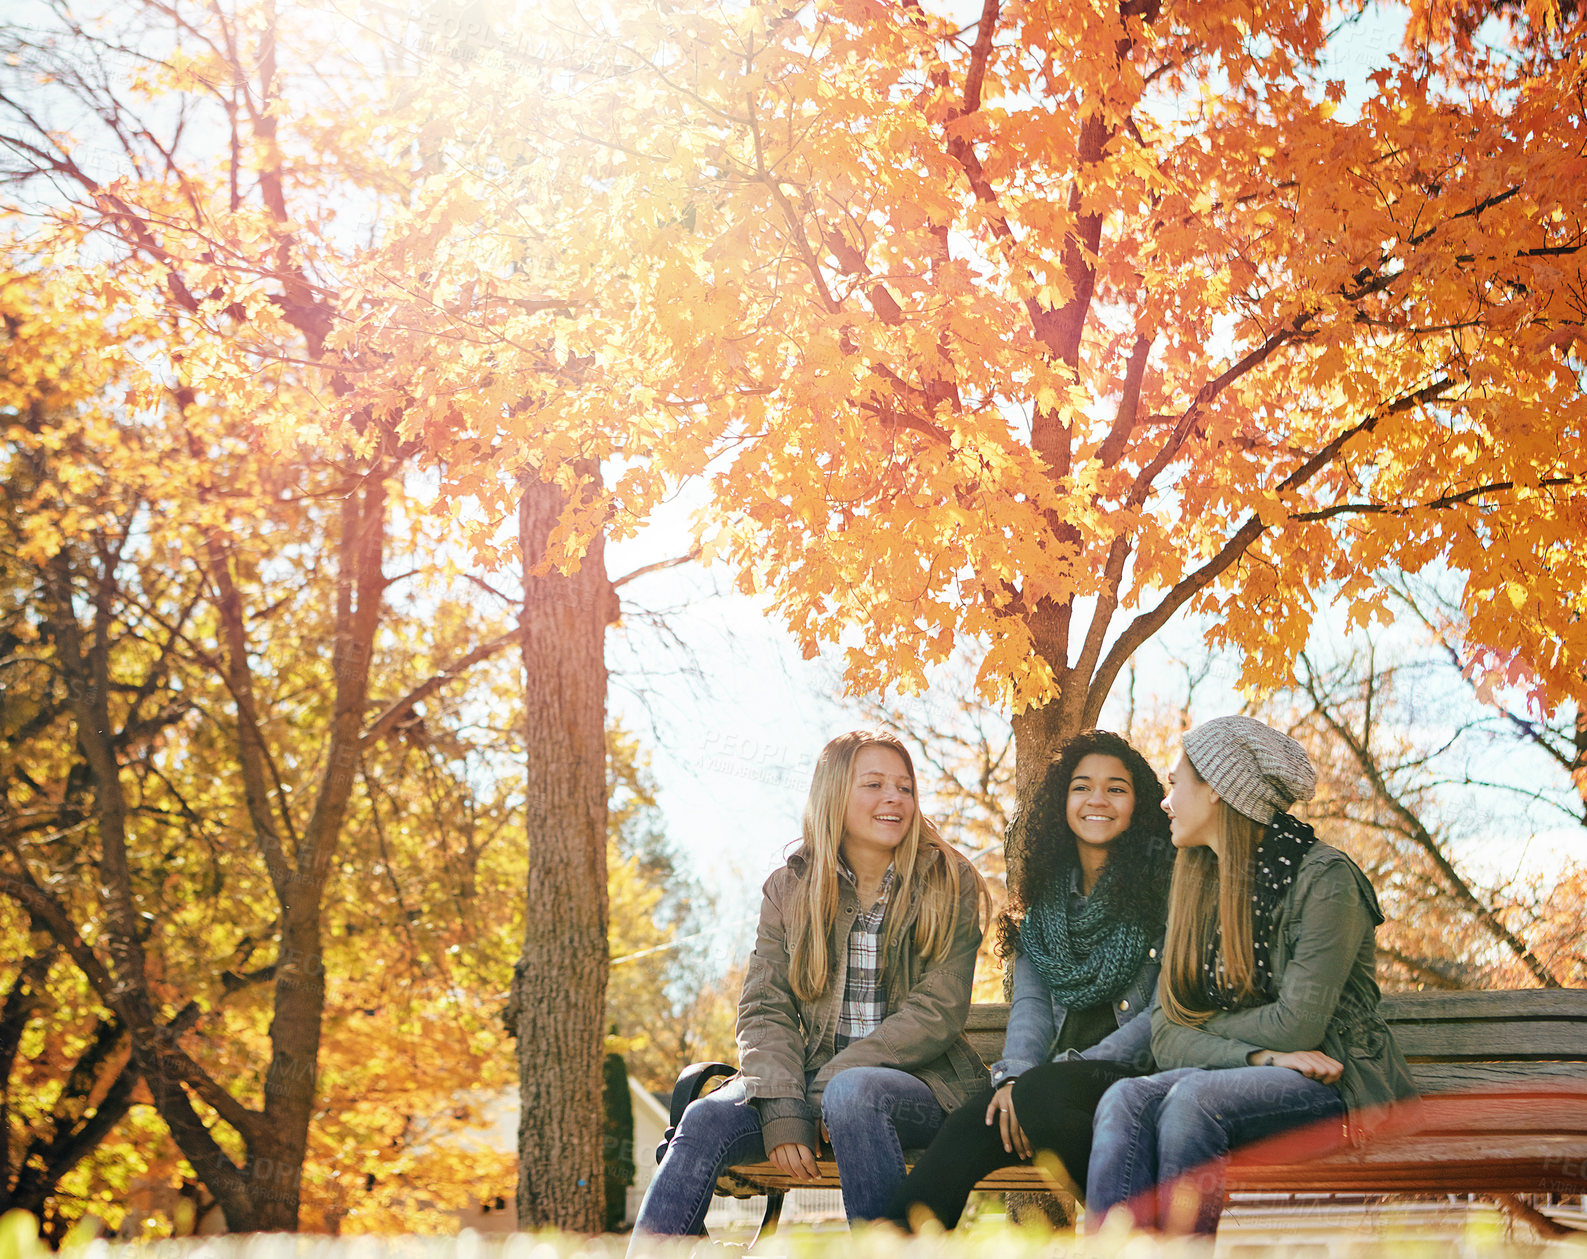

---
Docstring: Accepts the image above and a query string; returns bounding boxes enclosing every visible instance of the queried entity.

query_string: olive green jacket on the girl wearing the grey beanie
[1152,841,1416,1135]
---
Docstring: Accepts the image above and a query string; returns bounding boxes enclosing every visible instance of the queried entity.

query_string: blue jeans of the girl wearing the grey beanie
[1086,1067,1344,1234]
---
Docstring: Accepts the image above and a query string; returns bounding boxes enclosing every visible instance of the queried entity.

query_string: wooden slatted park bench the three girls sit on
[657,989,1587,1234]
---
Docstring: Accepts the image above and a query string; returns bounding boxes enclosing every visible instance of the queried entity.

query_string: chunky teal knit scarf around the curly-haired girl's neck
[1019,872,1151,1010]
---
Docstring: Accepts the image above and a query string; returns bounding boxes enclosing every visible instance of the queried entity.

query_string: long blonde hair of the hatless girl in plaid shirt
[789,730,986,1000]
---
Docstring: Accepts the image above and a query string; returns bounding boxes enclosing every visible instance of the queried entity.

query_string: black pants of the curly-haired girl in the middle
[887,1061,1141,1229]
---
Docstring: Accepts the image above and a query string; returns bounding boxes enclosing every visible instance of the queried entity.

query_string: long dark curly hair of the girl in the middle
[997,730,1174,961]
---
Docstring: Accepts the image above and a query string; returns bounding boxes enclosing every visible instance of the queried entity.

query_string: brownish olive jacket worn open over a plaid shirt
[738,846,987,1151]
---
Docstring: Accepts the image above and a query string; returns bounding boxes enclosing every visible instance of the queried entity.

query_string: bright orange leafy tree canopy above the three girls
[367,0,1584,790]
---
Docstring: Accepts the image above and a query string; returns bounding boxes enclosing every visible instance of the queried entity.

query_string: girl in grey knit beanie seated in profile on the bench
[1087,716,1416,1234]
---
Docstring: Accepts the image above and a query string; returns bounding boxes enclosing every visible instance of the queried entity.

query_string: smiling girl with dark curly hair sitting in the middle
[889,730,1173,1227]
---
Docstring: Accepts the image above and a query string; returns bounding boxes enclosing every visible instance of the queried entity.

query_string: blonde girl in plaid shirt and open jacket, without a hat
[635,730,986,1237]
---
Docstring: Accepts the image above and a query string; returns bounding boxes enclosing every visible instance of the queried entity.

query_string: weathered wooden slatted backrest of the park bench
[965,988,1587,1092]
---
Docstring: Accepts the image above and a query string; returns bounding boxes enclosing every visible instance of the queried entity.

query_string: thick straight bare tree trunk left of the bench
[513,465,617,1234]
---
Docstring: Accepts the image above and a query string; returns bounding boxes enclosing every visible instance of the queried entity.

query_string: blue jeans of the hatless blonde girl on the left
[633,1067,943,1238]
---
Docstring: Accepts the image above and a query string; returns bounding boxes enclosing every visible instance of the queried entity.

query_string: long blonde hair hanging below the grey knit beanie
[1157,757,1266,1027]
